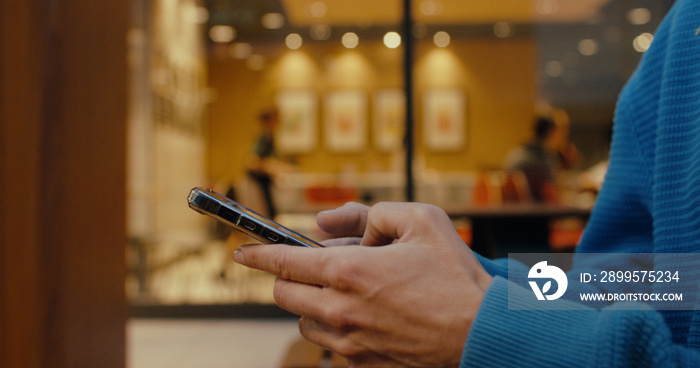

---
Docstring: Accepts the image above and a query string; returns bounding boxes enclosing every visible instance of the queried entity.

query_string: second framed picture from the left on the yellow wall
[324,90,367,152]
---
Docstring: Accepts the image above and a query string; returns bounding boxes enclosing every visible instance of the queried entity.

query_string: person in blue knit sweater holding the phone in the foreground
[228,0,700,367]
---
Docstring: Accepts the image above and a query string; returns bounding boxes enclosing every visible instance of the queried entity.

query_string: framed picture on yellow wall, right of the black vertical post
[423,88,465,151]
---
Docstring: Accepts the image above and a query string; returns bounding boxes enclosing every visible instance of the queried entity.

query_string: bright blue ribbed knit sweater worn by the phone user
[460,0,700,367]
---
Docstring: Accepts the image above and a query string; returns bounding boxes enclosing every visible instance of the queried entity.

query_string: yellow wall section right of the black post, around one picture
[416,39,537,171]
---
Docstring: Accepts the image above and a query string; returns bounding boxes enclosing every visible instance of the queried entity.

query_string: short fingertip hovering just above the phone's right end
[316,202,369,236]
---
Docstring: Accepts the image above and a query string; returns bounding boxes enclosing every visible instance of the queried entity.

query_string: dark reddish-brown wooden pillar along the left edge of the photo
[0,0,129,368]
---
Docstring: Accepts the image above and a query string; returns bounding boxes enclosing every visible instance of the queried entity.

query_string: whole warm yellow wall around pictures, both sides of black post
[208,38,536,181]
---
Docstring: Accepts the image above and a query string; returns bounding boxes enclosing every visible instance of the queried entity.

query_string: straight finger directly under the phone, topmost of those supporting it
[233,244,338,286]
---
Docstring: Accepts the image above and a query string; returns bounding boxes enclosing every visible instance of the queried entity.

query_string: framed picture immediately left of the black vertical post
[373,88,406,152]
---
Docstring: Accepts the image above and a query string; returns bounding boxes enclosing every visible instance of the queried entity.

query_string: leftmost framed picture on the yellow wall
[275,90,318,153]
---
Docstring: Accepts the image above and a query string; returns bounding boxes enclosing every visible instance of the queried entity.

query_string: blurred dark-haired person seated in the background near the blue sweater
[506,116,559,203]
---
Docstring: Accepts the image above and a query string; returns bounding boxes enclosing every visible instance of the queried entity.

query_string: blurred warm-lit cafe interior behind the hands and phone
[0,0,672,368]
